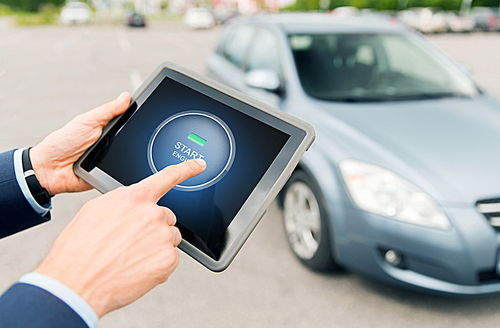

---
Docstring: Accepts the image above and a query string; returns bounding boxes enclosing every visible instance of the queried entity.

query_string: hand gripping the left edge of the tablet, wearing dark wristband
[30,92,130,195]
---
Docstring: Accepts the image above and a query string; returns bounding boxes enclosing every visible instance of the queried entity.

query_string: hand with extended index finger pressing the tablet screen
[35,160,206,317]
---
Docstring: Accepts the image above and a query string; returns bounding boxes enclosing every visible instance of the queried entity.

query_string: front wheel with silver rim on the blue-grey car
[280,170,339,271]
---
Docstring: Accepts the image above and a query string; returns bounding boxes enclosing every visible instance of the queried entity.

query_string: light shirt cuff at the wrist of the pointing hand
[19,272,99,328]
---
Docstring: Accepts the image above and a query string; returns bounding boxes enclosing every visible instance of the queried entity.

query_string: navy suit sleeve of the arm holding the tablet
[0,151,50,238]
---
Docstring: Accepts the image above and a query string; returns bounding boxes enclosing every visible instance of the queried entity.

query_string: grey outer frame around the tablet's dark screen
[74,63,315,272]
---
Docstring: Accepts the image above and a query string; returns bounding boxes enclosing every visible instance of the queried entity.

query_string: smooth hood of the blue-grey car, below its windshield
[309,95,500,205]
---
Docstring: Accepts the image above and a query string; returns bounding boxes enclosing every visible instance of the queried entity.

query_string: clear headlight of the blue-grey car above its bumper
[340,160,451,229]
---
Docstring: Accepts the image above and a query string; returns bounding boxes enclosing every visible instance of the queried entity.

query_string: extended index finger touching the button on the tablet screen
[138,159,207,202]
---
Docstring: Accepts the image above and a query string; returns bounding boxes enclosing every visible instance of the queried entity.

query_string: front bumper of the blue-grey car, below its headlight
[333,205,500,295]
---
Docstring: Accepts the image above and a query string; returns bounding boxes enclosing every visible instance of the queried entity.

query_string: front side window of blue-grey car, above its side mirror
[246,28,280,74]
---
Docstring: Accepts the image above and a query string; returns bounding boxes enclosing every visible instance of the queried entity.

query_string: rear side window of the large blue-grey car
[222,26,255,67]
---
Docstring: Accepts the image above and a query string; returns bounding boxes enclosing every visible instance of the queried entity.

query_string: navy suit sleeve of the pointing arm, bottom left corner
[0,283,88,328]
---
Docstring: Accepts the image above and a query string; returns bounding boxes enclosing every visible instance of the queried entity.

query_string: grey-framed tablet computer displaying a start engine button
[75,64,314,271]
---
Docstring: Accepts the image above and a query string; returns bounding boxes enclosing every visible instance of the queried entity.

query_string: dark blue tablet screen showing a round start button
[82,77,290,260]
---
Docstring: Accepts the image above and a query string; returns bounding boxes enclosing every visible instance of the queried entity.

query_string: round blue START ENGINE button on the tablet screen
[148,110,236,191]
